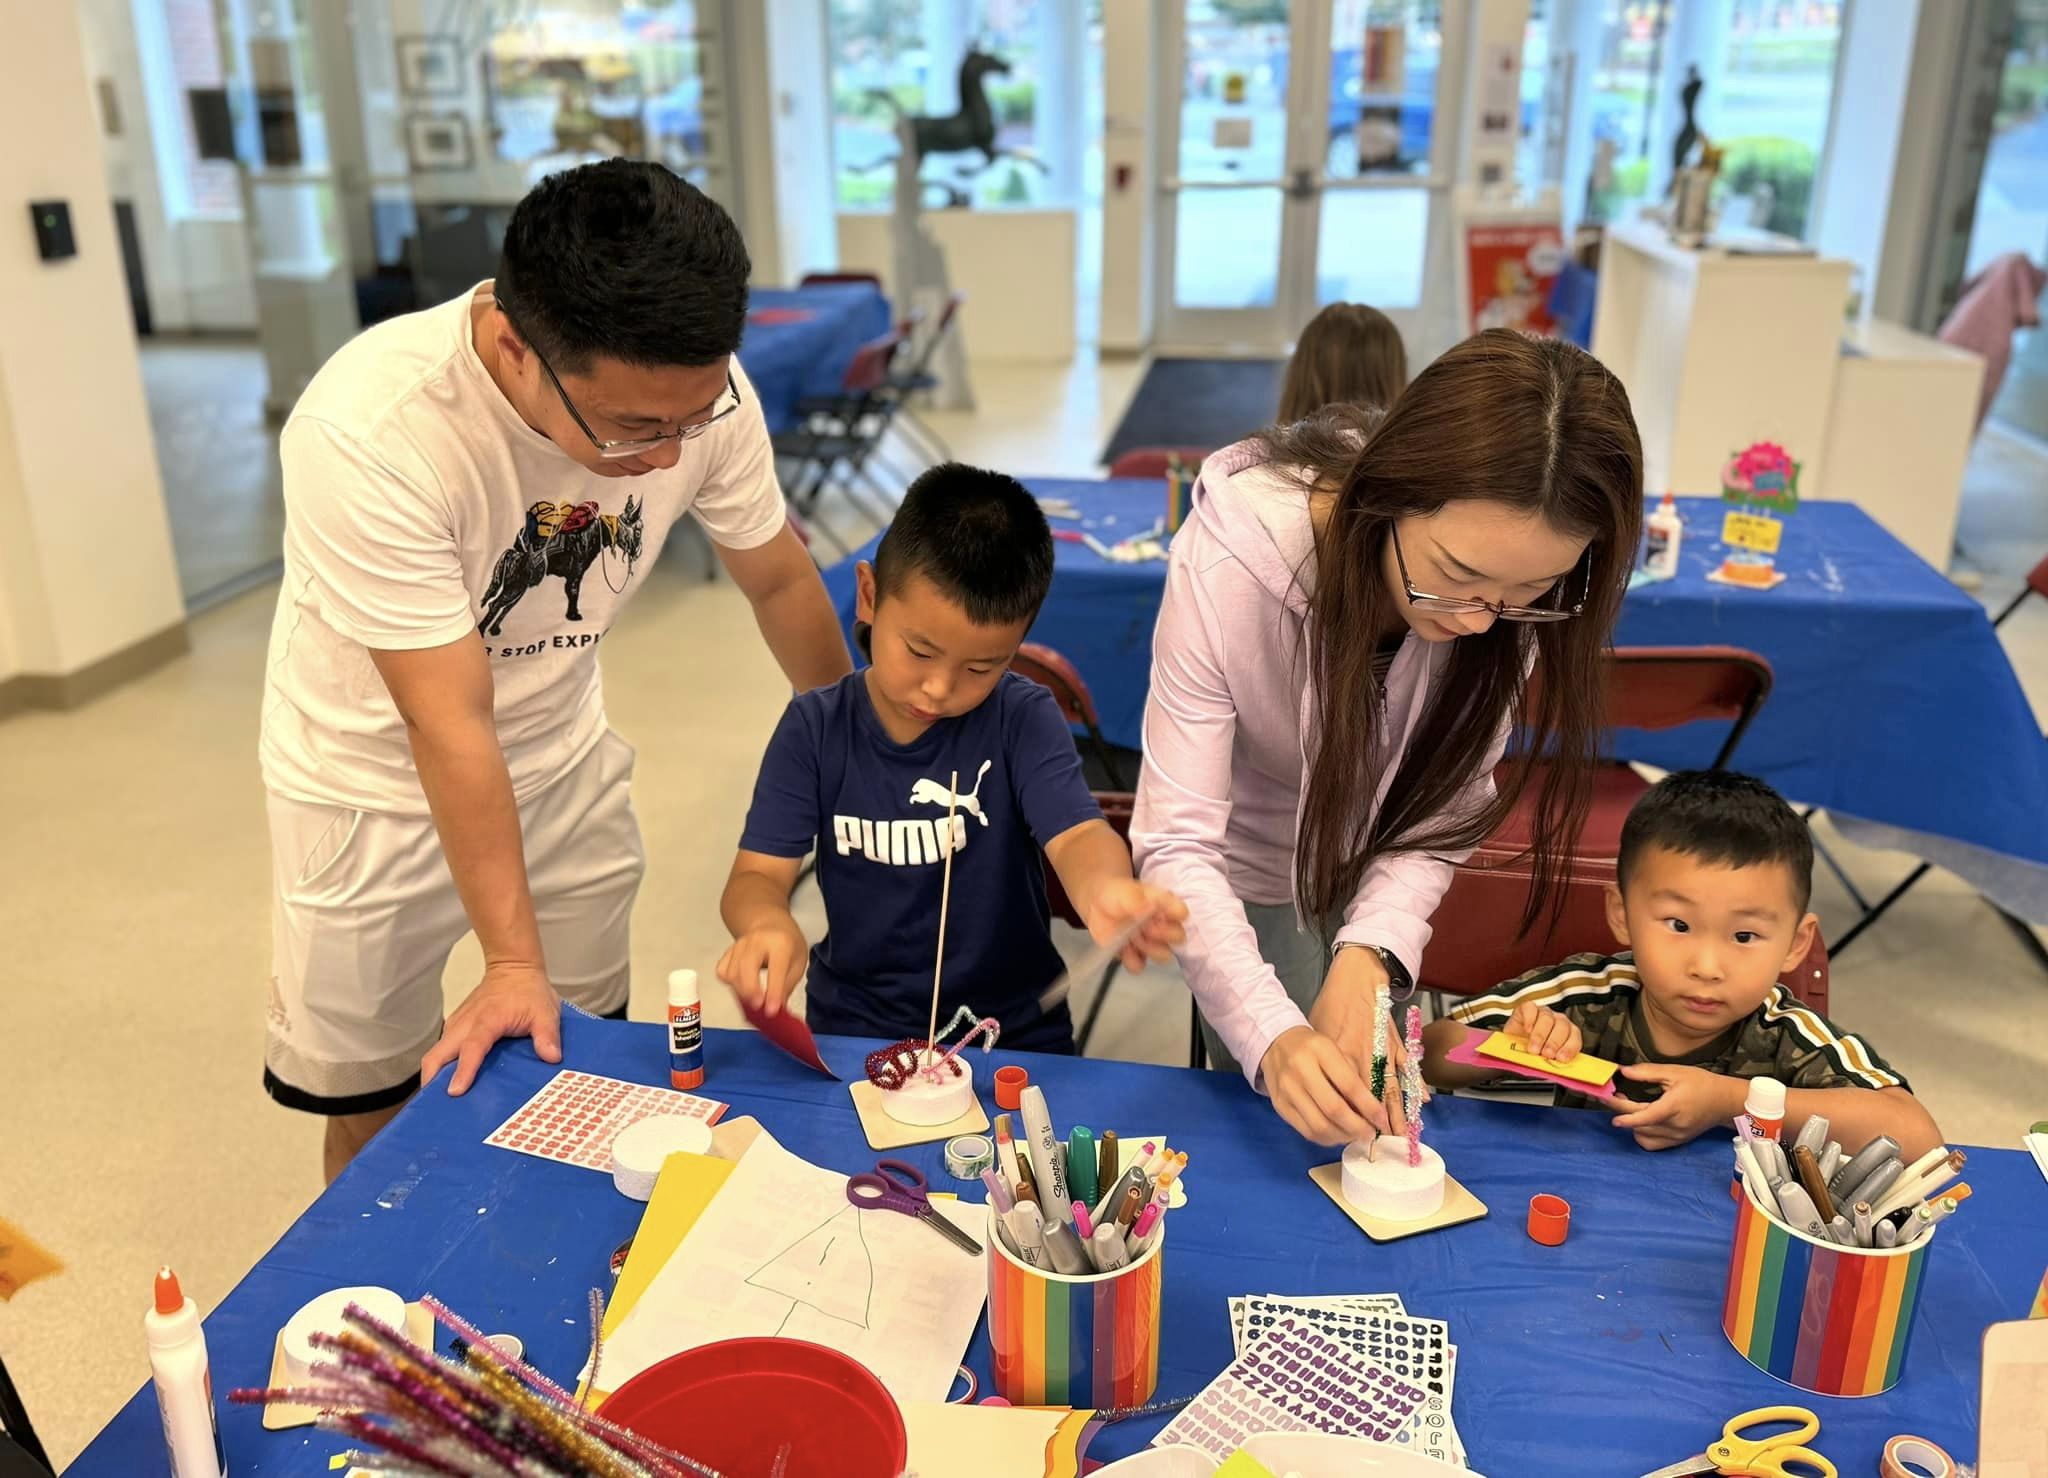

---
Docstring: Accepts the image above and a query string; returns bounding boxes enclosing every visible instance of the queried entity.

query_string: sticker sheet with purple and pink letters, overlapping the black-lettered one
[1151,1318,1430,1460]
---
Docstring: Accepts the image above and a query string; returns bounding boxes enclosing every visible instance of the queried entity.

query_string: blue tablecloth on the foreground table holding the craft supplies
[70,1013,2048,1478]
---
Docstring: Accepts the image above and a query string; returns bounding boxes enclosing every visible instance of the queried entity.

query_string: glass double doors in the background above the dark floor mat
[1155,0,1468,354]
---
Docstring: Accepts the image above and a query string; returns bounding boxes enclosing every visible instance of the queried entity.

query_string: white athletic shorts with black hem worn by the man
[264,729,647,1114]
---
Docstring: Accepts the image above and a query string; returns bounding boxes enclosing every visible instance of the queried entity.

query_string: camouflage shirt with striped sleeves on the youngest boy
[1450,954,1909,1112]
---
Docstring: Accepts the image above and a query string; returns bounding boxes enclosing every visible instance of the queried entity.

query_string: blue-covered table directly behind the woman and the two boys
[823,477,2048,923]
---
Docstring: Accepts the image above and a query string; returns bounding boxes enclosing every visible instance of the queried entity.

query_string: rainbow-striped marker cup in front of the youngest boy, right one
[1720,1162,1942,1396]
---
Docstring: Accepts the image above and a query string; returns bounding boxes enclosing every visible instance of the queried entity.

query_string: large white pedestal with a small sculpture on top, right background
[1593,221,1855,497]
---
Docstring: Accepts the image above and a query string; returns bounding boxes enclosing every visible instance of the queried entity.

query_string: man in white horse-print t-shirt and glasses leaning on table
[262,160,850,1179]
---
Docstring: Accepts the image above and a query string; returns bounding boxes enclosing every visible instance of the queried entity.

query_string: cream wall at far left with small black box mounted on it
[0,6,184,676]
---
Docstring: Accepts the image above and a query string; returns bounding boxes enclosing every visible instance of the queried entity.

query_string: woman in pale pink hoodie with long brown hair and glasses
[1130,330,1642,1144]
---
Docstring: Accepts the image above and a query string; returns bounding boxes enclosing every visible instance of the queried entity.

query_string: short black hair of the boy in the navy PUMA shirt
[874,463,1053,626]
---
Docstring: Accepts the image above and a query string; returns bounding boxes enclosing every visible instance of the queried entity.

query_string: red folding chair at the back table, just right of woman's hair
[1487,647,1772,859]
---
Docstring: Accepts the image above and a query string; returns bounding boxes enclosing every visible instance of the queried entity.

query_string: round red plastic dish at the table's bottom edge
[600,1339,909,1478]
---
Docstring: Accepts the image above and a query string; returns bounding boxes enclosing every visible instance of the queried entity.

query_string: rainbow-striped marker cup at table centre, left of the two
[985,1216,1165,1410]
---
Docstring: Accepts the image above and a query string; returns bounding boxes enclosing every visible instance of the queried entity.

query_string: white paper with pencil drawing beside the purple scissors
[604,1136,987,1400]
